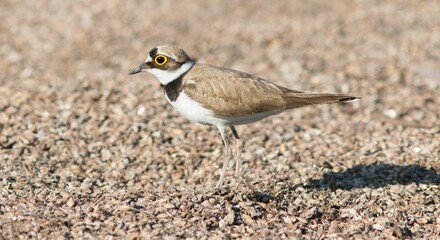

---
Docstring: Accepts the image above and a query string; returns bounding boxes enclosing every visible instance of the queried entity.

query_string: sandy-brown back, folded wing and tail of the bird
[183,64,355,117]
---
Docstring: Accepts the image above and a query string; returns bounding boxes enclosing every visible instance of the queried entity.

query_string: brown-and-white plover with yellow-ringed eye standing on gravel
[129,44,360,188]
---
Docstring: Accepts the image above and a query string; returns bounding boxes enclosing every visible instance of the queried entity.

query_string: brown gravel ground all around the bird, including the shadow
[0,0,440,239]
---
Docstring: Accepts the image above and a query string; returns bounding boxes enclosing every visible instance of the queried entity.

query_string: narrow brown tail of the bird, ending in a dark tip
[283,92,361,109]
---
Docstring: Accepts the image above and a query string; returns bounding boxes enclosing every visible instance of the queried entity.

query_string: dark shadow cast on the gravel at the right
[306,163,440,191]
